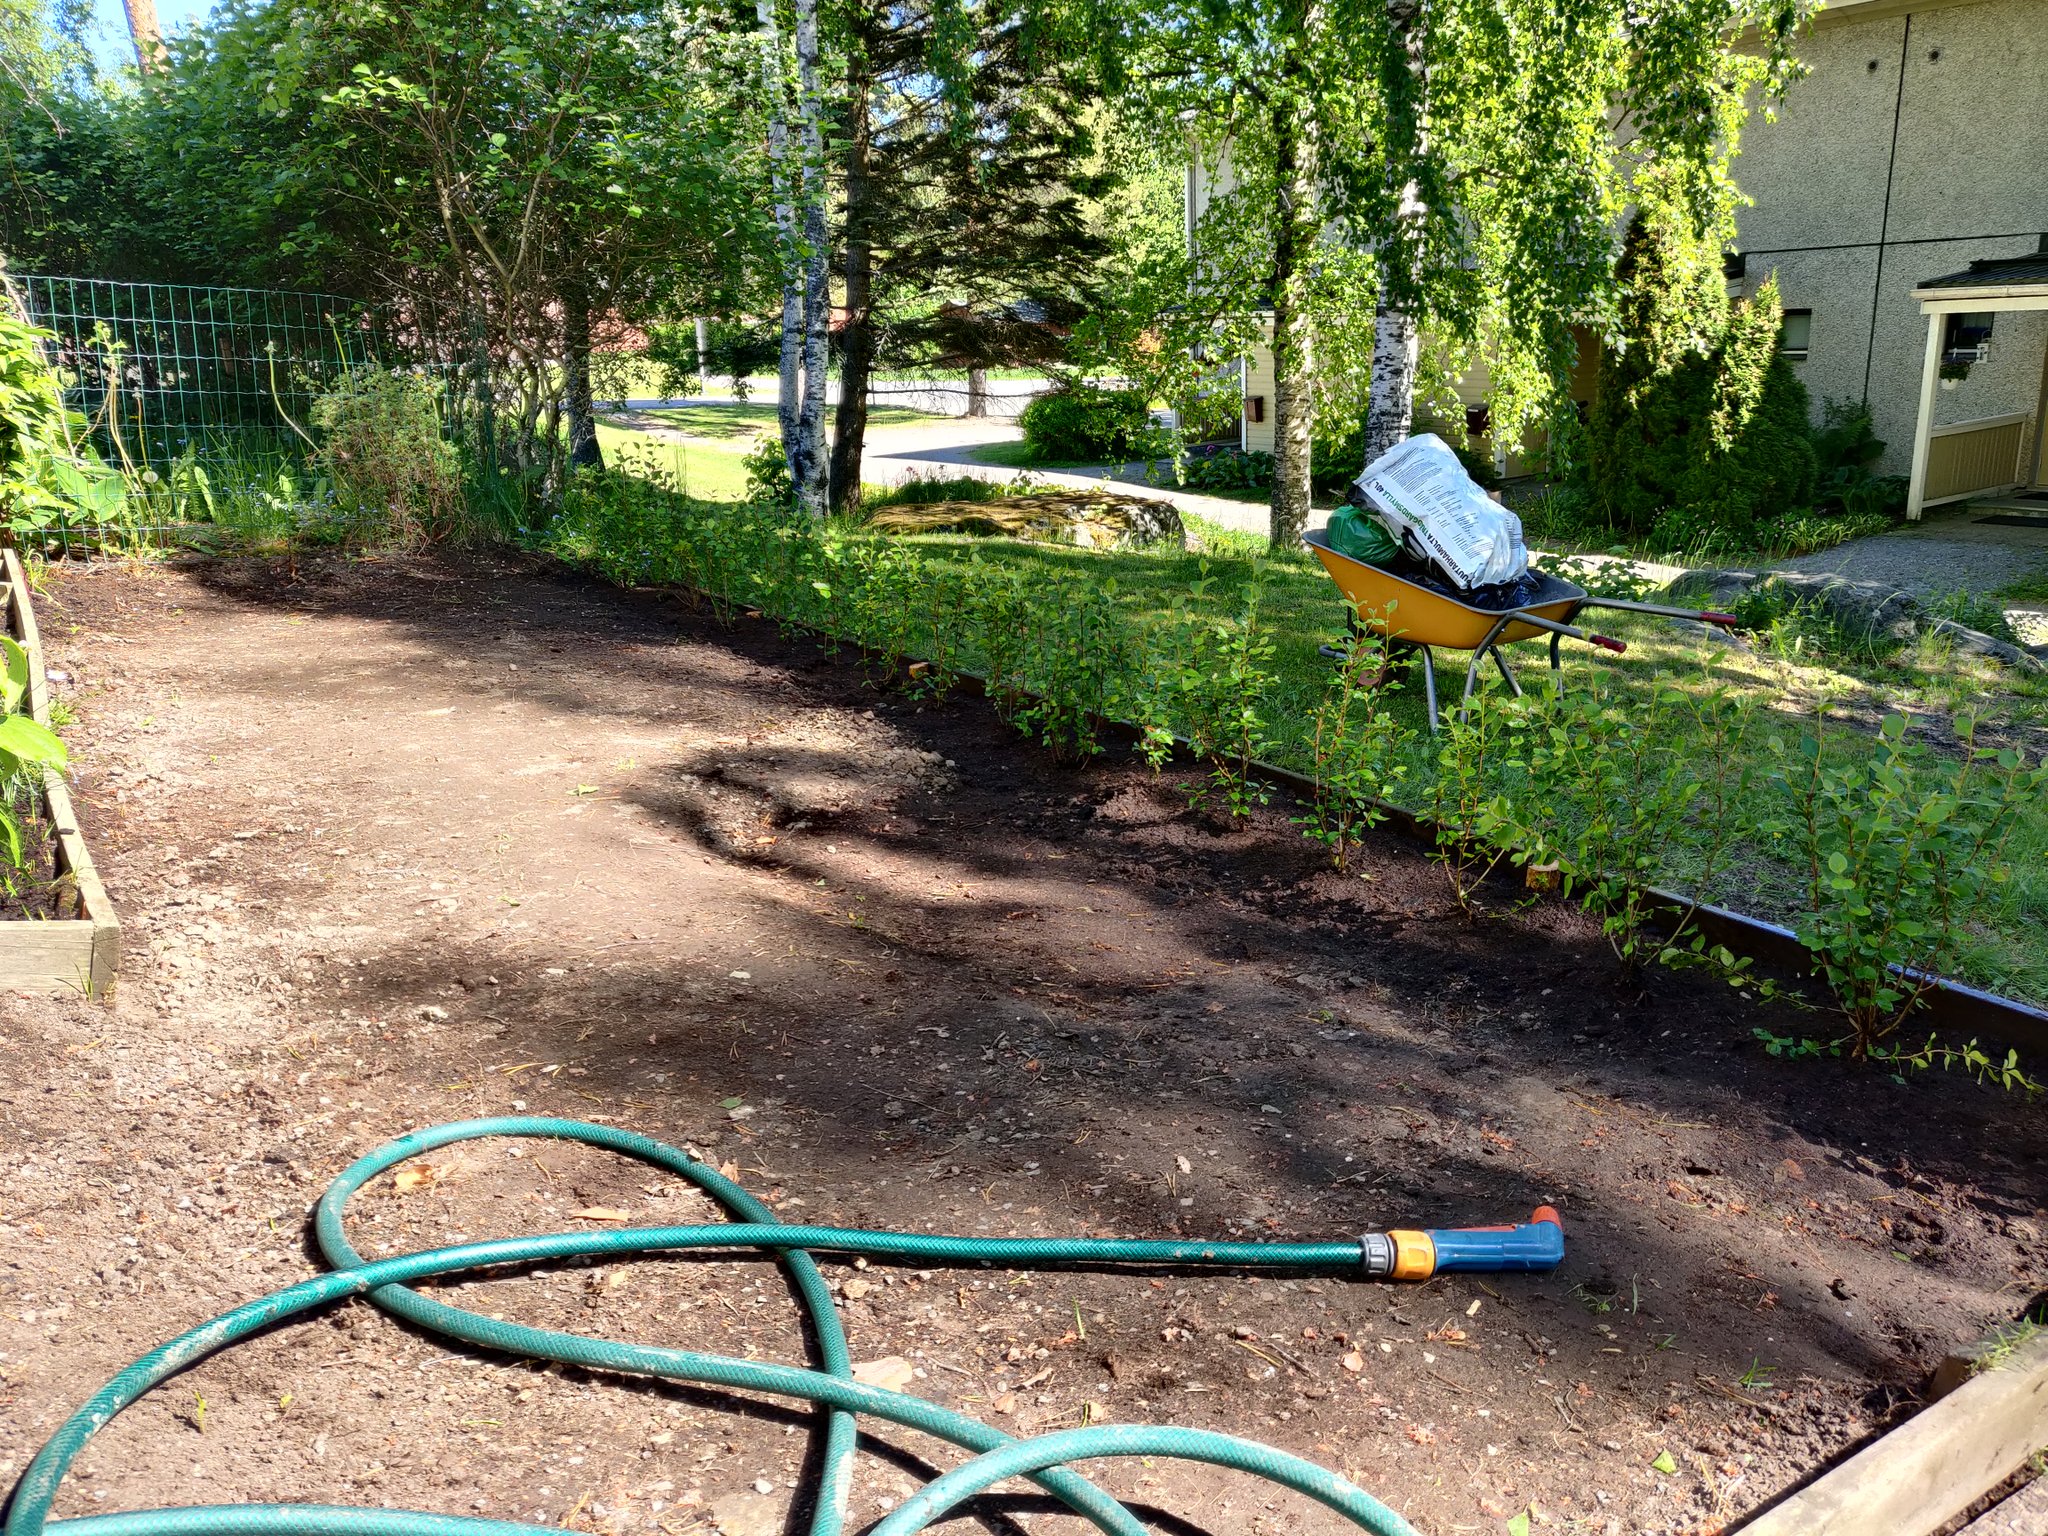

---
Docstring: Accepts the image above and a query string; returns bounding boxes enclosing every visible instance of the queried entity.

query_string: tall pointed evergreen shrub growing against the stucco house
[1587,178,1817,545]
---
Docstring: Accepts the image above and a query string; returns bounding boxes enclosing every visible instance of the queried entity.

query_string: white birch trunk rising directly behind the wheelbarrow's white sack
[1366,0,1432,465]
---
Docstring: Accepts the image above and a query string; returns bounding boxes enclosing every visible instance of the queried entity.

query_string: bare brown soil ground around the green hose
[0,559,2048,1536]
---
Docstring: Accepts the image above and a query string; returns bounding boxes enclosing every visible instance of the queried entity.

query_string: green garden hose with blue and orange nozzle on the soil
[4,1116,1565,1536]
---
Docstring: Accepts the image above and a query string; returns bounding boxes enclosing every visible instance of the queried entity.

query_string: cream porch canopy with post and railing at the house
[1907,250,2048,518]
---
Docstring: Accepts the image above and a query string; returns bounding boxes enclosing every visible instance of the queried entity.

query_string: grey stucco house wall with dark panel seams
[1735,0,2048,473]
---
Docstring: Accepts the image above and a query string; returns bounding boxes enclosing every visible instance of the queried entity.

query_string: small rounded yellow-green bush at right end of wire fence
[313,369,463,545]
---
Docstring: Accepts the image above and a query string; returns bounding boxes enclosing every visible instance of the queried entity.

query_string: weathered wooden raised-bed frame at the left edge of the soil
[0,549,121,997]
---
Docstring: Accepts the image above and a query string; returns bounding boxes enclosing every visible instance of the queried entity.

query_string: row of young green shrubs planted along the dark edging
[551,473,2048,1083]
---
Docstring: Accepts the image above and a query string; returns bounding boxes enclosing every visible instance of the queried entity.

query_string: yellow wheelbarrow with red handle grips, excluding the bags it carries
[1300,528,1735,731]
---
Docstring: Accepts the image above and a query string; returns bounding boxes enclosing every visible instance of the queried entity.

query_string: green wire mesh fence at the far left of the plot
[8,272,379,553]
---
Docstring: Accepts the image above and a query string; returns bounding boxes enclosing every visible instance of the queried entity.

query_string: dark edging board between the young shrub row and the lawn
[692,588,2048,1057]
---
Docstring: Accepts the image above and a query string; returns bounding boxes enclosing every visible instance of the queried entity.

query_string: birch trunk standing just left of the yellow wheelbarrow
[1268,60,1319,551]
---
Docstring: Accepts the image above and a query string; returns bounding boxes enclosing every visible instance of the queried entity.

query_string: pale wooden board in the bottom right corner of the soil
[1733,1331,2048,1536]
